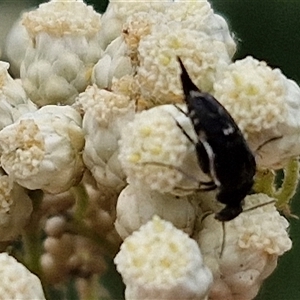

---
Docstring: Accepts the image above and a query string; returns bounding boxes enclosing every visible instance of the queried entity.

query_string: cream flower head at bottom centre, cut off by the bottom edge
[114,216,212,300]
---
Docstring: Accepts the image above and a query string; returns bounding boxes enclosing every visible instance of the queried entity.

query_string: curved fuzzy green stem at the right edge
[274,158,300,209]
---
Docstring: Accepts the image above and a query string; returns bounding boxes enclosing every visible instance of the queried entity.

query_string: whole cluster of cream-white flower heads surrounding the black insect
[0,0,300,300]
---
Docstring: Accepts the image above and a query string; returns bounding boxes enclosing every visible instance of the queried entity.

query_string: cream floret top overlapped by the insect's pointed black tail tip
[137,24,230,105]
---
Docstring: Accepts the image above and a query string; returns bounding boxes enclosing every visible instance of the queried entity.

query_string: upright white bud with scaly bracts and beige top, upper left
[21,0,102,106]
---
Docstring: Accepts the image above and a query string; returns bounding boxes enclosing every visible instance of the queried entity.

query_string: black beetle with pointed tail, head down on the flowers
[178,58,256,221]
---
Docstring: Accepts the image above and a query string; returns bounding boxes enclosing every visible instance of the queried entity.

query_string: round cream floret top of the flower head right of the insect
[214,57,287,135]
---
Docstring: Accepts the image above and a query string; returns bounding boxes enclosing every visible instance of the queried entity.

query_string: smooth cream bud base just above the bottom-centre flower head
[115,185,197,239]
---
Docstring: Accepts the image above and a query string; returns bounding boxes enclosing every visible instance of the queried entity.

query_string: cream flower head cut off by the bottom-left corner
[0,253,46,300]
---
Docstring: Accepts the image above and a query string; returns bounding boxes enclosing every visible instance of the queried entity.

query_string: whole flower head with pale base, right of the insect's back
[214,57,300,169]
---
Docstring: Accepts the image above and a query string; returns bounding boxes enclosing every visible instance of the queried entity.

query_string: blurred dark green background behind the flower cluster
[0,0,300,300]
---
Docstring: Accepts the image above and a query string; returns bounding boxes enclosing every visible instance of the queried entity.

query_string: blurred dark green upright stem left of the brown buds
[22,190,44,278]
